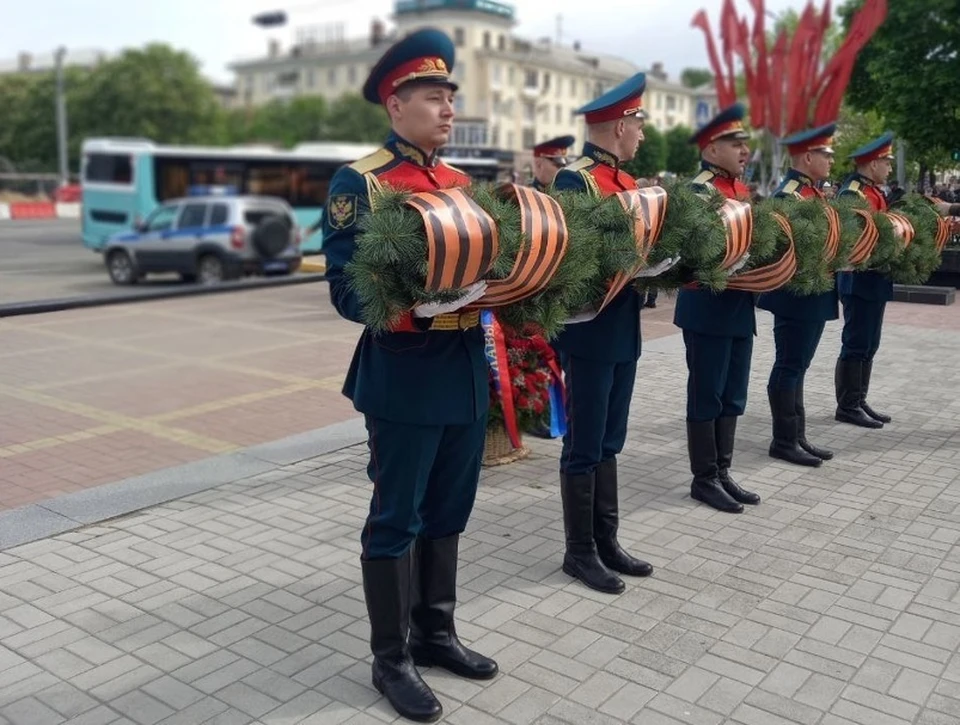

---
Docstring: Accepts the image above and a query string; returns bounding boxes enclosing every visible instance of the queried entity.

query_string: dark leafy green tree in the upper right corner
[840,0,960,181]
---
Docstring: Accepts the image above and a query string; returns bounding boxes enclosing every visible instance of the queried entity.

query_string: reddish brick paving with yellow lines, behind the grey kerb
[0,283,675,511]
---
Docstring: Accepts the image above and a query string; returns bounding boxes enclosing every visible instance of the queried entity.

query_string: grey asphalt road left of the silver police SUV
[0,219,191,304]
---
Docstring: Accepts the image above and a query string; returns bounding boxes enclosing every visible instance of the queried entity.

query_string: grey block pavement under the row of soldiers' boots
[0,316,960,725]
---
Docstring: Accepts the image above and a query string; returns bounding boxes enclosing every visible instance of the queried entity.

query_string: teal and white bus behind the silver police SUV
[81,137,510,254]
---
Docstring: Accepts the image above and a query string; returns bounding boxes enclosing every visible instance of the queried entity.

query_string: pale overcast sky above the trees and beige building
[0,0,804,81]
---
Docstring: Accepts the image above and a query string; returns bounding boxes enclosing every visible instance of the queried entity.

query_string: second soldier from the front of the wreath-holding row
[553,73,653,594]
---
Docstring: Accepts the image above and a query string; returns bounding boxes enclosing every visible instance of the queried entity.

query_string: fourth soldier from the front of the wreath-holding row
[757,123,839,466]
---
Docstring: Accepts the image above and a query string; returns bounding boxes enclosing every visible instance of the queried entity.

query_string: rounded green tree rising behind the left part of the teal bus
[70,43,220,151]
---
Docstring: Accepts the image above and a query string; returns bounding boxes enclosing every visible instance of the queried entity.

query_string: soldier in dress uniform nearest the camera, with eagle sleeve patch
[323,28,497,722]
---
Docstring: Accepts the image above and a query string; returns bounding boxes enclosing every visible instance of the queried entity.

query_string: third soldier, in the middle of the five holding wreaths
[673,103,760,513]
